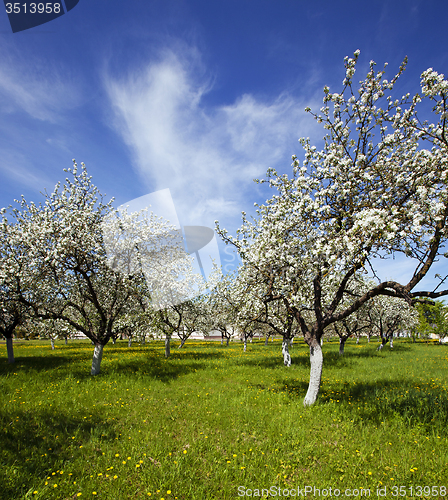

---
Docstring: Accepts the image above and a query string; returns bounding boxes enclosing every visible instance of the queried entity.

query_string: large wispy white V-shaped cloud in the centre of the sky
[105,45,320,229]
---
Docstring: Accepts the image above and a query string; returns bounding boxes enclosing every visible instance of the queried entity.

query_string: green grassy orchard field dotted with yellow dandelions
[0,340,448,500]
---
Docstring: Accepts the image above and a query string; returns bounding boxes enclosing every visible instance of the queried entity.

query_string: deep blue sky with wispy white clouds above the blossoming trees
[0,0,448,294]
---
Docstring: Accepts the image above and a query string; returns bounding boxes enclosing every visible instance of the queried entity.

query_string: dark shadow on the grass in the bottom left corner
[0,408,117,500]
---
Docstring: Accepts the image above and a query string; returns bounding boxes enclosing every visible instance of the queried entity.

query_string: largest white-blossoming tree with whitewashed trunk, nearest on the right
[217,51,448,405]
